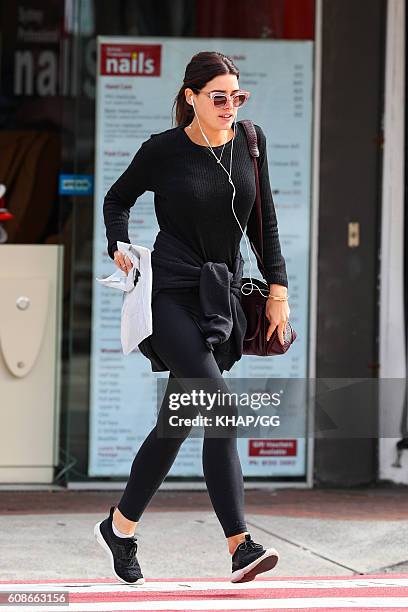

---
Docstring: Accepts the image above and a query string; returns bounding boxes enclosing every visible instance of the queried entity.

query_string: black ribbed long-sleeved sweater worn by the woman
[103,123,288,287]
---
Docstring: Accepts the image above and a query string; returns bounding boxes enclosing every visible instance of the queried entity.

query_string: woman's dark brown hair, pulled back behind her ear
[172,51,239,126]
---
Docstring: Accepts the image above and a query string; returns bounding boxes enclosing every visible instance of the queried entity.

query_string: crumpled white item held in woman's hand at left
[96,241,153,355]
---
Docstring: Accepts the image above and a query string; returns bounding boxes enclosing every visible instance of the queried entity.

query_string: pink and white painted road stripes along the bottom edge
[0,574,408,612]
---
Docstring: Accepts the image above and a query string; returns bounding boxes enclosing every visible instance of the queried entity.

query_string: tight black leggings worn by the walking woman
[118,289,247,537]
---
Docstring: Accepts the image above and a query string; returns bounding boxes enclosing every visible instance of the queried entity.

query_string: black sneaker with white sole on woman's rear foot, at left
[94,506,145,584]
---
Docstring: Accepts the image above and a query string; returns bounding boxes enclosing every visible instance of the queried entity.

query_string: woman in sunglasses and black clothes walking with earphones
[94,52,289,584]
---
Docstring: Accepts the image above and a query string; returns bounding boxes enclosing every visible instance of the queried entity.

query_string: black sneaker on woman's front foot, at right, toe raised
[231,533,279,582]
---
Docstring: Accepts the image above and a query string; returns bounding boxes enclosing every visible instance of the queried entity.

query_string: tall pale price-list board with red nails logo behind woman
[89,37,313,478]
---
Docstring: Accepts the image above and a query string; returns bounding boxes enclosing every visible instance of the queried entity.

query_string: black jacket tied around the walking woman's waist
[138,230,247,372]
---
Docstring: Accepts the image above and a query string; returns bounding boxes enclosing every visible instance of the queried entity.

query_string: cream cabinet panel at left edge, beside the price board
[0,244,63,483]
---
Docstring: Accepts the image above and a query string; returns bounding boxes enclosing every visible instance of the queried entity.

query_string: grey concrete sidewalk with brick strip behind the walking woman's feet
[0,486,408,581]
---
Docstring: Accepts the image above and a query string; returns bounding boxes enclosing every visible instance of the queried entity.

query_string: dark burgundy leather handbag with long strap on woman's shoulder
[239,119,297,356]
